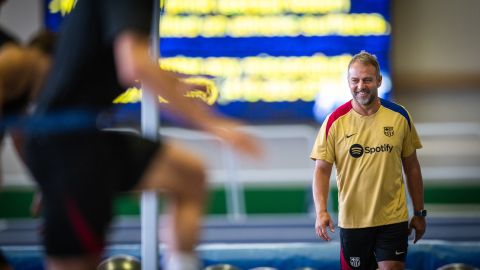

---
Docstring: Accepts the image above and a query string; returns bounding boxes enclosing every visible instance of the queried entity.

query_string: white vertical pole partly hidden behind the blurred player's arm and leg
[140,0,160,270]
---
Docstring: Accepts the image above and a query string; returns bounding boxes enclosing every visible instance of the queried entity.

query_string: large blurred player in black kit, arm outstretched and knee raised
[26,0,259,270]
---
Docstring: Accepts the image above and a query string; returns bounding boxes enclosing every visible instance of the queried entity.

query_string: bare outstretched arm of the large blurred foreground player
[114,31,260,155]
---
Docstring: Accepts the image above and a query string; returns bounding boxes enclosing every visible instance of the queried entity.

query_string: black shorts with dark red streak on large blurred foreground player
[26,131,161,257]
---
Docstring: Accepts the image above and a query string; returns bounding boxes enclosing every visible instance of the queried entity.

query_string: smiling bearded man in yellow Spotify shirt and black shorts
[310,51,426,269]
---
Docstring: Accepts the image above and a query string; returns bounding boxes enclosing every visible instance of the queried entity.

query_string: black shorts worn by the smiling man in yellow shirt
[340,222,408,269]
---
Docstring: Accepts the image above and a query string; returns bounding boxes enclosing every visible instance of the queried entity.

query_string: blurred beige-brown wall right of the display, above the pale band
[392,0,480,122]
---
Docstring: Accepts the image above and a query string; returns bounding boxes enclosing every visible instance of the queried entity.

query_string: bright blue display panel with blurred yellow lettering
[45,0,391,123]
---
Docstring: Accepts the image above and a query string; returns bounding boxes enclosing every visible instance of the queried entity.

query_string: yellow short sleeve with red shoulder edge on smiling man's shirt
[310,115,335,164]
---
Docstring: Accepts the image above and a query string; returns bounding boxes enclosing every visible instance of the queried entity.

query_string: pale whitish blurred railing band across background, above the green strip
[2,123,480,210]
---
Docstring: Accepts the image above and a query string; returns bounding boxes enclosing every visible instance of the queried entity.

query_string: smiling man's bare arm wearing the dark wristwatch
[402,151,427,243]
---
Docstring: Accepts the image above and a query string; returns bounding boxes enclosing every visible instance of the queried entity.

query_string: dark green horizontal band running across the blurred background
[0,184,480,218]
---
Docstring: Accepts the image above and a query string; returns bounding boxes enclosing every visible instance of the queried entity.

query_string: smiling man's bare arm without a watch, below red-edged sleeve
[312,159,334,241]
